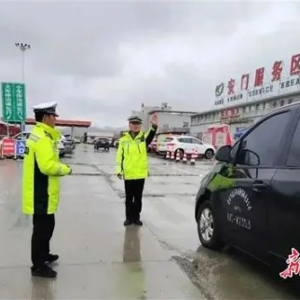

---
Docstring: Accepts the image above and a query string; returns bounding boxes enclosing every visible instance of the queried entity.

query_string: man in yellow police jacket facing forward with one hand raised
[116,114,157,226]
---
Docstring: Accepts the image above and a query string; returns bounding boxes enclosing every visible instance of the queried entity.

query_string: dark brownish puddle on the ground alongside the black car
[172,247,299,300]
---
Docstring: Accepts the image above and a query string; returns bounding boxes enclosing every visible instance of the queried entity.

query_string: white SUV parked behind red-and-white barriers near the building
[156,135,216,159]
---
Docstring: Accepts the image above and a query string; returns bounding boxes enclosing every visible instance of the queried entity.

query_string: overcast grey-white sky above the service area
[0,0,300,126]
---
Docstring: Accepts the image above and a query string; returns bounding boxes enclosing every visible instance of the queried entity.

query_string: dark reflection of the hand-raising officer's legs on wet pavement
[123,226,142,263]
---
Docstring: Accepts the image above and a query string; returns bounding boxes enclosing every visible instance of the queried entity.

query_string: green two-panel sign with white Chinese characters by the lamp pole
[1,82,26,123]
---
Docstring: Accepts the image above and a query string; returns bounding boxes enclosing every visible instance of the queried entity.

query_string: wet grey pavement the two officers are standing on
[0,146,297,299]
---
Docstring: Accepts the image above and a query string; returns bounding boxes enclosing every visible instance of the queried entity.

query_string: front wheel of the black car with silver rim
[197,200,224,250]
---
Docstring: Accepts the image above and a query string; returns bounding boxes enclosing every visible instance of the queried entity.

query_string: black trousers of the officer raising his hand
[125,179,145,221]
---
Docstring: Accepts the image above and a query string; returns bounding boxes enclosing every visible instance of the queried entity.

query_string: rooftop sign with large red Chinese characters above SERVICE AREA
[215,54,300,105]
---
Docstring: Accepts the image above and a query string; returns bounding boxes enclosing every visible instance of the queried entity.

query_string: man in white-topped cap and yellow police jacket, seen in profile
[22,102,72,278]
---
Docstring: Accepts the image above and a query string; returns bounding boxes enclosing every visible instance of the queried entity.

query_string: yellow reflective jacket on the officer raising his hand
[116,127,157,180]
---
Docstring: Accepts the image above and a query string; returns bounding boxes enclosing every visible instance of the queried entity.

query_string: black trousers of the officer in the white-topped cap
[31,214,55,268]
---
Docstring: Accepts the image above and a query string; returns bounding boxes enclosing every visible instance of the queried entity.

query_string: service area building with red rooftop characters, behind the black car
[190,54,300,137]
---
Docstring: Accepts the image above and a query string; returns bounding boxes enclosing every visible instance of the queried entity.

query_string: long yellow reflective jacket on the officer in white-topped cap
[22,123,70,215]
